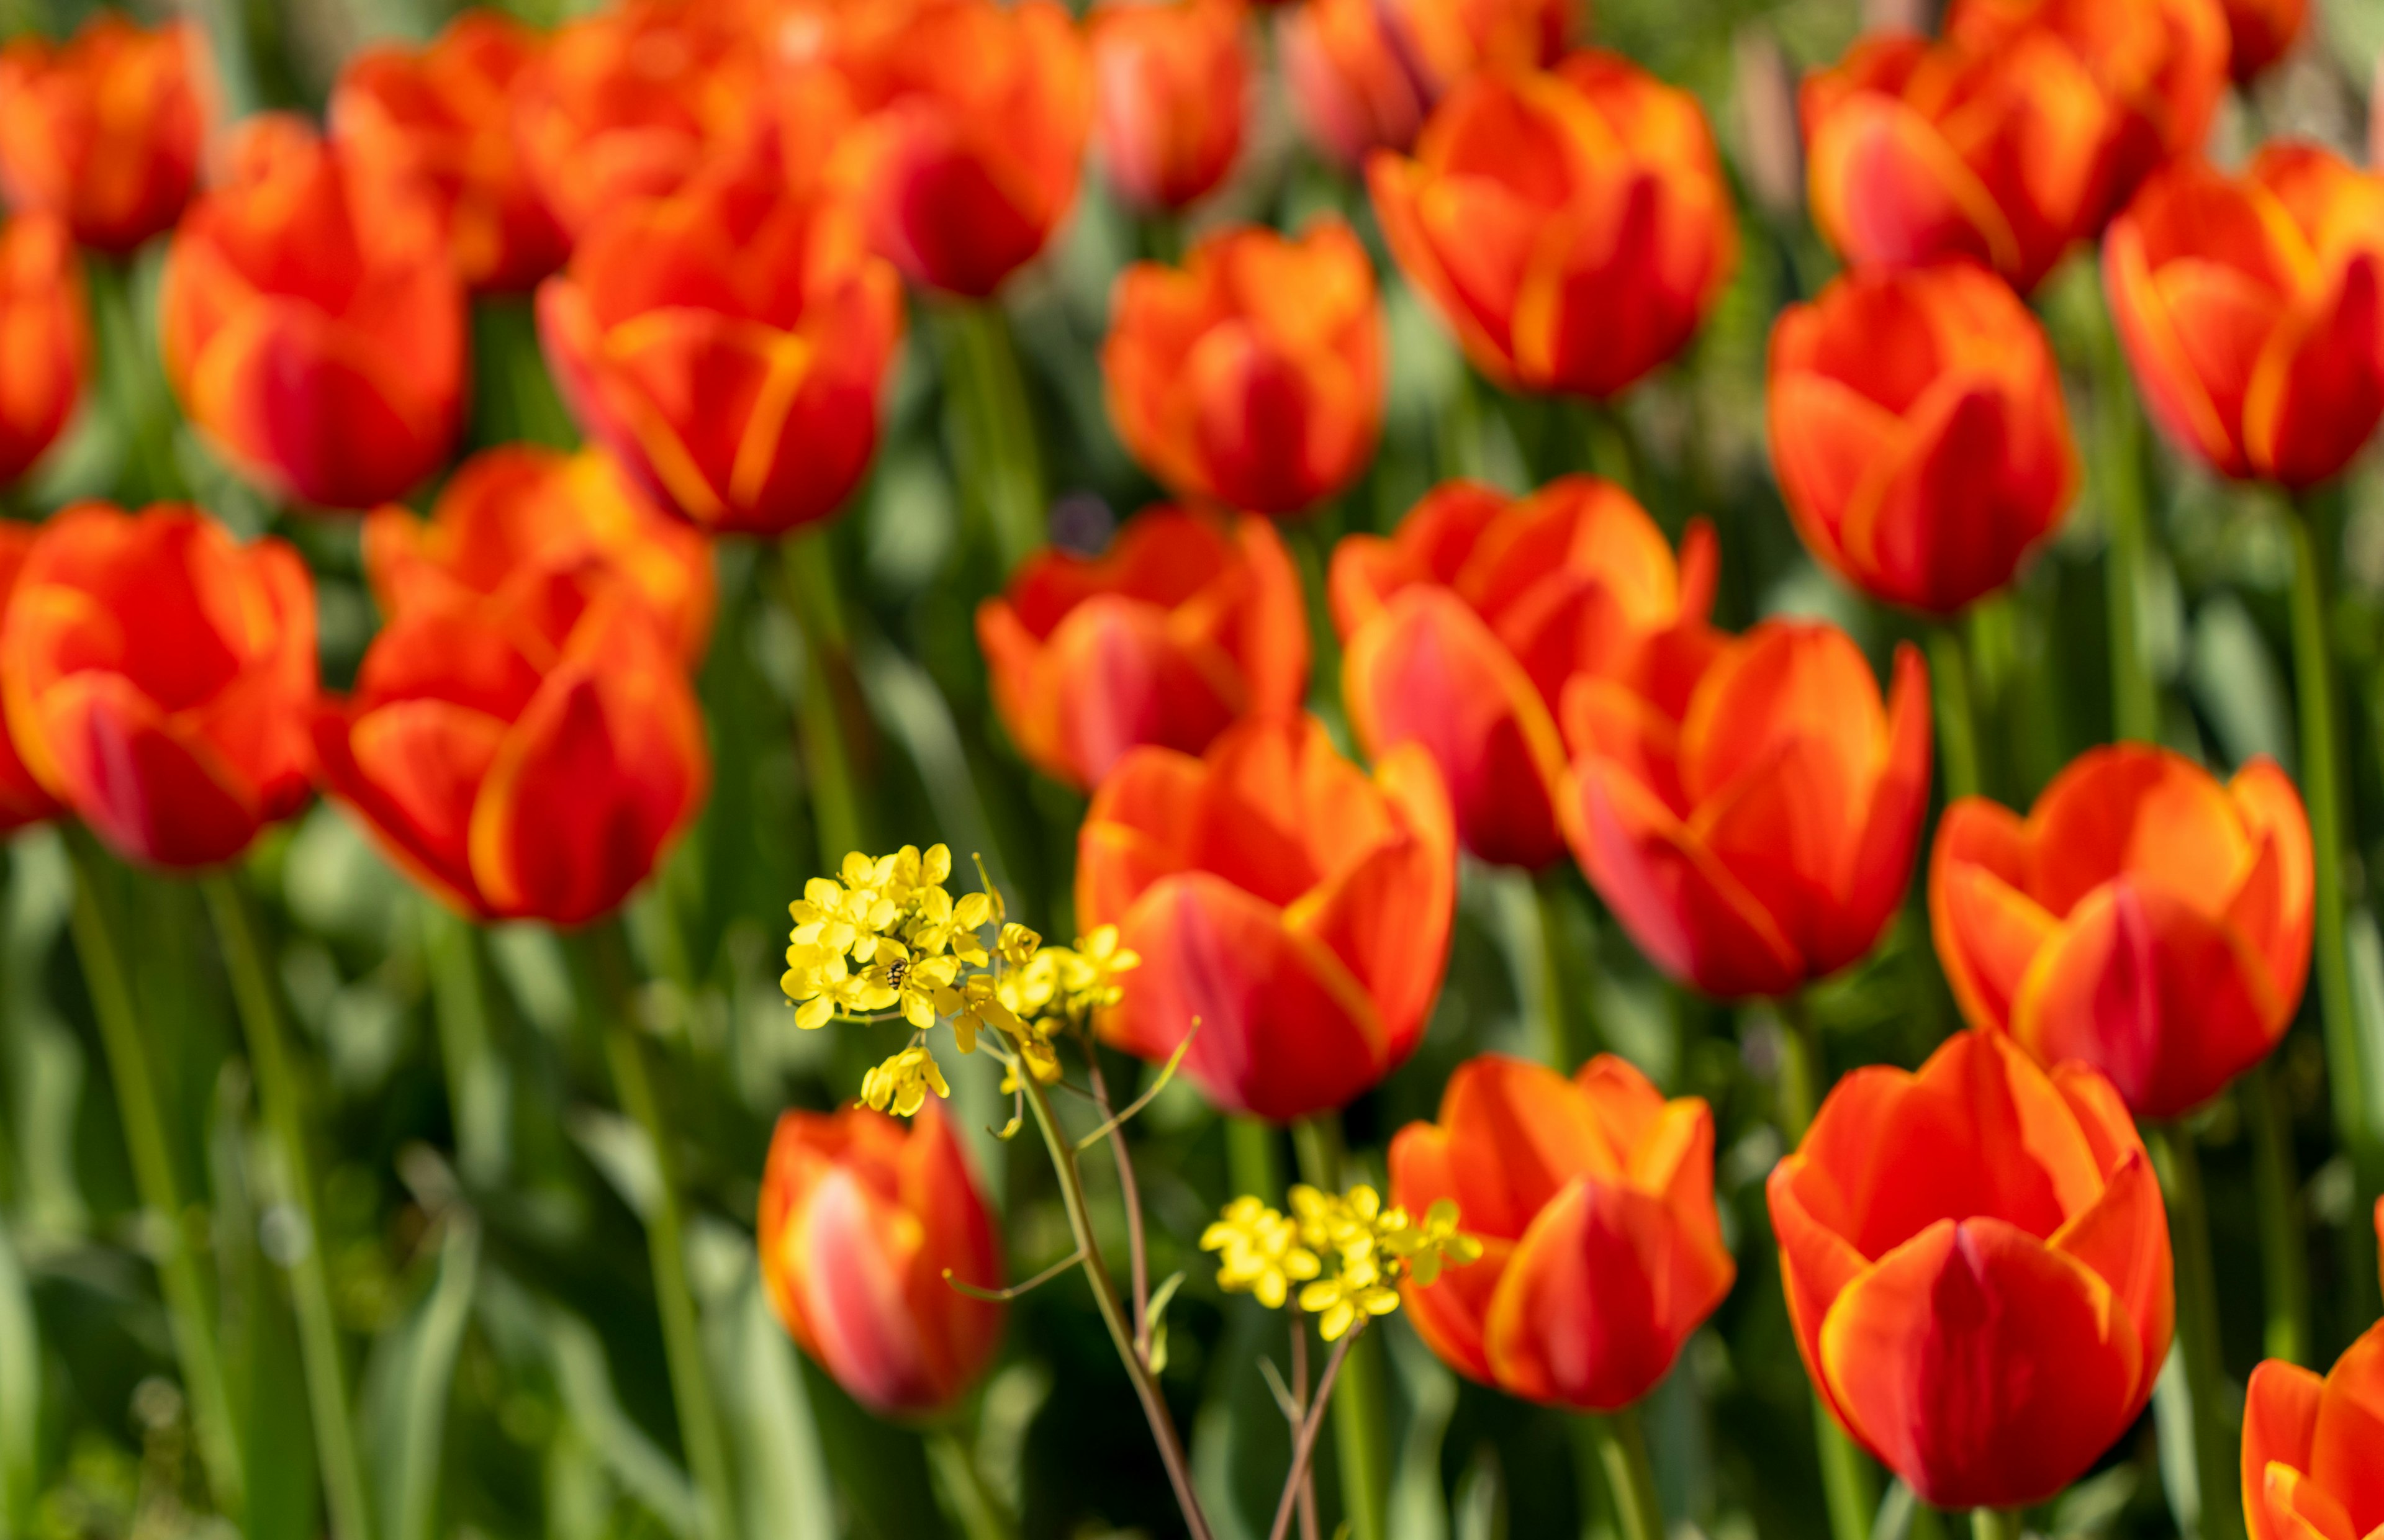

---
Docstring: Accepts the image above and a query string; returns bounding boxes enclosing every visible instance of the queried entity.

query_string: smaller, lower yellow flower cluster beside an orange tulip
[1199,1182,1483,1342]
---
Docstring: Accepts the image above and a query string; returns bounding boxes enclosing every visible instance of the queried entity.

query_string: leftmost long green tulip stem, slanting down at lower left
[67,825,248,1518]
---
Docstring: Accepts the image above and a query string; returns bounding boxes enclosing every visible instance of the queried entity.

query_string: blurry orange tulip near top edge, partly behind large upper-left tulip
[332,9,570,291]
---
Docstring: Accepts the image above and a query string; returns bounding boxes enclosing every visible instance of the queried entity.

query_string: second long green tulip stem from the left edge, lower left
[201,873,372,1540]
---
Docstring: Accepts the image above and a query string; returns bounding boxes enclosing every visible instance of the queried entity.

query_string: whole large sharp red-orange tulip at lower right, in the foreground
[1766,1032,2177,1509]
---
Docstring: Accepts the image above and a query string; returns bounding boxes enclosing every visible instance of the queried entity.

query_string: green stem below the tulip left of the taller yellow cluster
[584,918,737,1540]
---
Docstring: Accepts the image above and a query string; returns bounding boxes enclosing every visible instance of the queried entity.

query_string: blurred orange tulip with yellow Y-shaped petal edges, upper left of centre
[539,145,901,534]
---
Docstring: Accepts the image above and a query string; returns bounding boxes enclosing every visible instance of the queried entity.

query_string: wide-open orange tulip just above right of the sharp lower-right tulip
[1929,744,2315,1118]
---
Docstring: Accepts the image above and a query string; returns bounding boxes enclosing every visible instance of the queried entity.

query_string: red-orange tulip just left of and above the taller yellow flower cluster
[312,572,710,925]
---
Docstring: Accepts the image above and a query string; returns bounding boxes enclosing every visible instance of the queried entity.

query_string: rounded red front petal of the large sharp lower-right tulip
[1822,1218,2153,1509]
